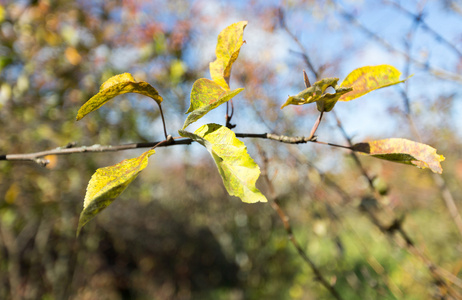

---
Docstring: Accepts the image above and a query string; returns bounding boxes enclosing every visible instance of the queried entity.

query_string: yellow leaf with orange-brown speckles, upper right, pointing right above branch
[339,65,409,101]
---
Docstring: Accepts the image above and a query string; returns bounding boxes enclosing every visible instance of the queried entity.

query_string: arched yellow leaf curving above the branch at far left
[76,73,163,121]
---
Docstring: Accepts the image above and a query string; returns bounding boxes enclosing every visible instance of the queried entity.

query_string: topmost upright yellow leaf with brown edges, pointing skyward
[210,21,247,90]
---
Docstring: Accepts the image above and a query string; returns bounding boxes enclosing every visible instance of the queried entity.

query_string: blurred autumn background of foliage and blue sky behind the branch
[0,0,462,300]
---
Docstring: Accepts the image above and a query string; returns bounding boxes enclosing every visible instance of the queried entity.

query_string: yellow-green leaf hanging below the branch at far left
[77,150,155,235]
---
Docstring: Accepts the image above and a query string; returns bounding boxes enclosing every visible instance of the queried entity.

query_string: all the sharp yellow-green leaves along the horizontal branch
[77,21,444,234]
